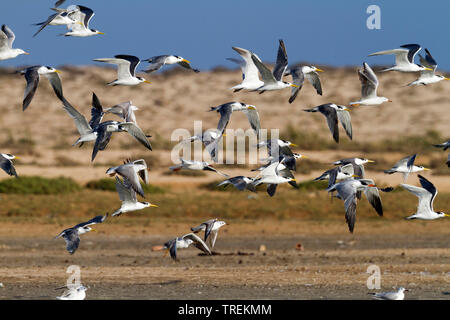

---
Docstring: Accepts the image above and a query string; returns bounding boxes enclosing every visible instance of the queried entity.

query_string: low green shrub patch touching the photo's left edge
[0,176,81,194]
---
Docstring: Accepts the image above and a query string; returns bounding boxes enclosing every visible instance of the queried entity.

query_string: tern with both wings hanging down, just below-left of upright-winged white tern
[303,103,353,142]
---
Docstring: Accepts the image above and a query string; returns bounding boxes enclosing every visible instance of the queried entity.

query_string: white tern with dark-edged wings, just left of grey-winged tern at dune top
[94,54,150,86]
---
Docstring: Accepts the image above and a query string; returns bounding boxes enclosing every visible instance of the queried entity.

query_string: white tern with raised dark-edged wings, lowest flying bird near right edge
[400,174,450,220]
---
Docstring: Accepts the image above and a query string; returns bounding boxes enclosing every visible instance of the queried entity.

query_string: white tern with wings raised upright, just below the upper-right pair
[349,62,392,107]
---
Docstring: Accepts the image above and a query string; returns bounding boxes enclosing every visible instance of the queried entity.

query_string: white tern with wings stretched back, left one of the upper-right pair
[369,44,432,72]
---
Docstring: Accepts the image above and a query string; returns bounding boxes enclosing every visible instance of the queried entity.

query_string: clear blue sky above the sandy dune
[0,0,450,70]
